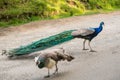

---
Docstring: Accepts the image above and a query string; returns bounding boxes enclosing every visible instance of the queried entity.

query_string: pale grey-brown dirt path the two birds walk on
[0,11,120,80]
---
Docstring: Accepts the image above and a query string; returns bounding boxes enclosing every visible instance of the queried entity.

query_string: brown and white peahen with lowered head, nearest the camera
[34,48,74,77]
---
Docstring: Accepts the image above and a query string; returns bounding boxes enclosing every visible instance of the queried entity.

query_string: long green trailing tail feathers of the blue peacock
[8,30,74,56]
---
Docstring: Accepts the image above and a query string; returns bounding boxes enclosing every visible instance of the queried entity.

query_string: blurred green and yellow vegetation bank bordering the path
[0,0,120,27]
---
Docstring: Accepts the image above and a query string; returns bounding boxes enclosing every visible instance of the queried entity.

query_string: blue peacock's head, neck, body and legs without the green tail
[71,22,104,52]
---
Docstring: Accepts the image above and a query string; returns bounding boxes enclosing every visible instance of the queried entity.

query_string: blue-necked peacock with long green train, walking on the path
[2,22,104,57]
